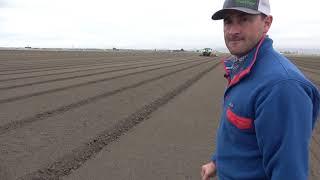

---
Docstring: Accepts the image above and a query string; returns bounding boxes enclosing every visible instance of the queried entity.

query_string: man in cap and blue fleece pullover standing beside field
[201,0,320,180]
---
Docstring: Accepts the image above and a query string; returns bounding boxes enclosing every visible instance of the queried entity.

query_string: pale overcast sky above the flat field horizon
[0,0,320,49]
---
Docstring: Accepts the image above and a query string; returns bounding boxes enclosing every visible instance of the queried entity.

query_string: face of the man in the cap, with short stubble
[223,10,272,57]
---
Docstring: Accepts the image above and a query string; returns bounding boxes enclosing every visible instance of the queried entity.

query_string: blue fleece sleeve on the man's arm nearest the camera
[254,80,313,180]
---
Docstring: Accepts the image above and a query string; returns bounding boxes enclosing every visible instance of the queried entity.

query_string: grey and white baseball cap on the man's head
[212,0,270,20]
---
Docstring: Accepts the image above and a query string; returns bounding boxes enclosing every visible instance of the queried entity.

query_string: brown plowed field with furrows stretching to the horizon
[0,50,320,180]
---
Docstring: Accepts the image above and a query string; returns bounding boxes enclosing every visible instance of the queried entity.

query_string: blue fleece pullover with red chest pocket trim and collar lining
[212,37,320,180]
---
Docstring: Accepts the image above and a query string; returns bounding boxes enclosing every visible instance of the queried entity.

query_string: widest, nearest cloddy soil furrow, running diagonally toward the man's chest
[19,59,218,180]
